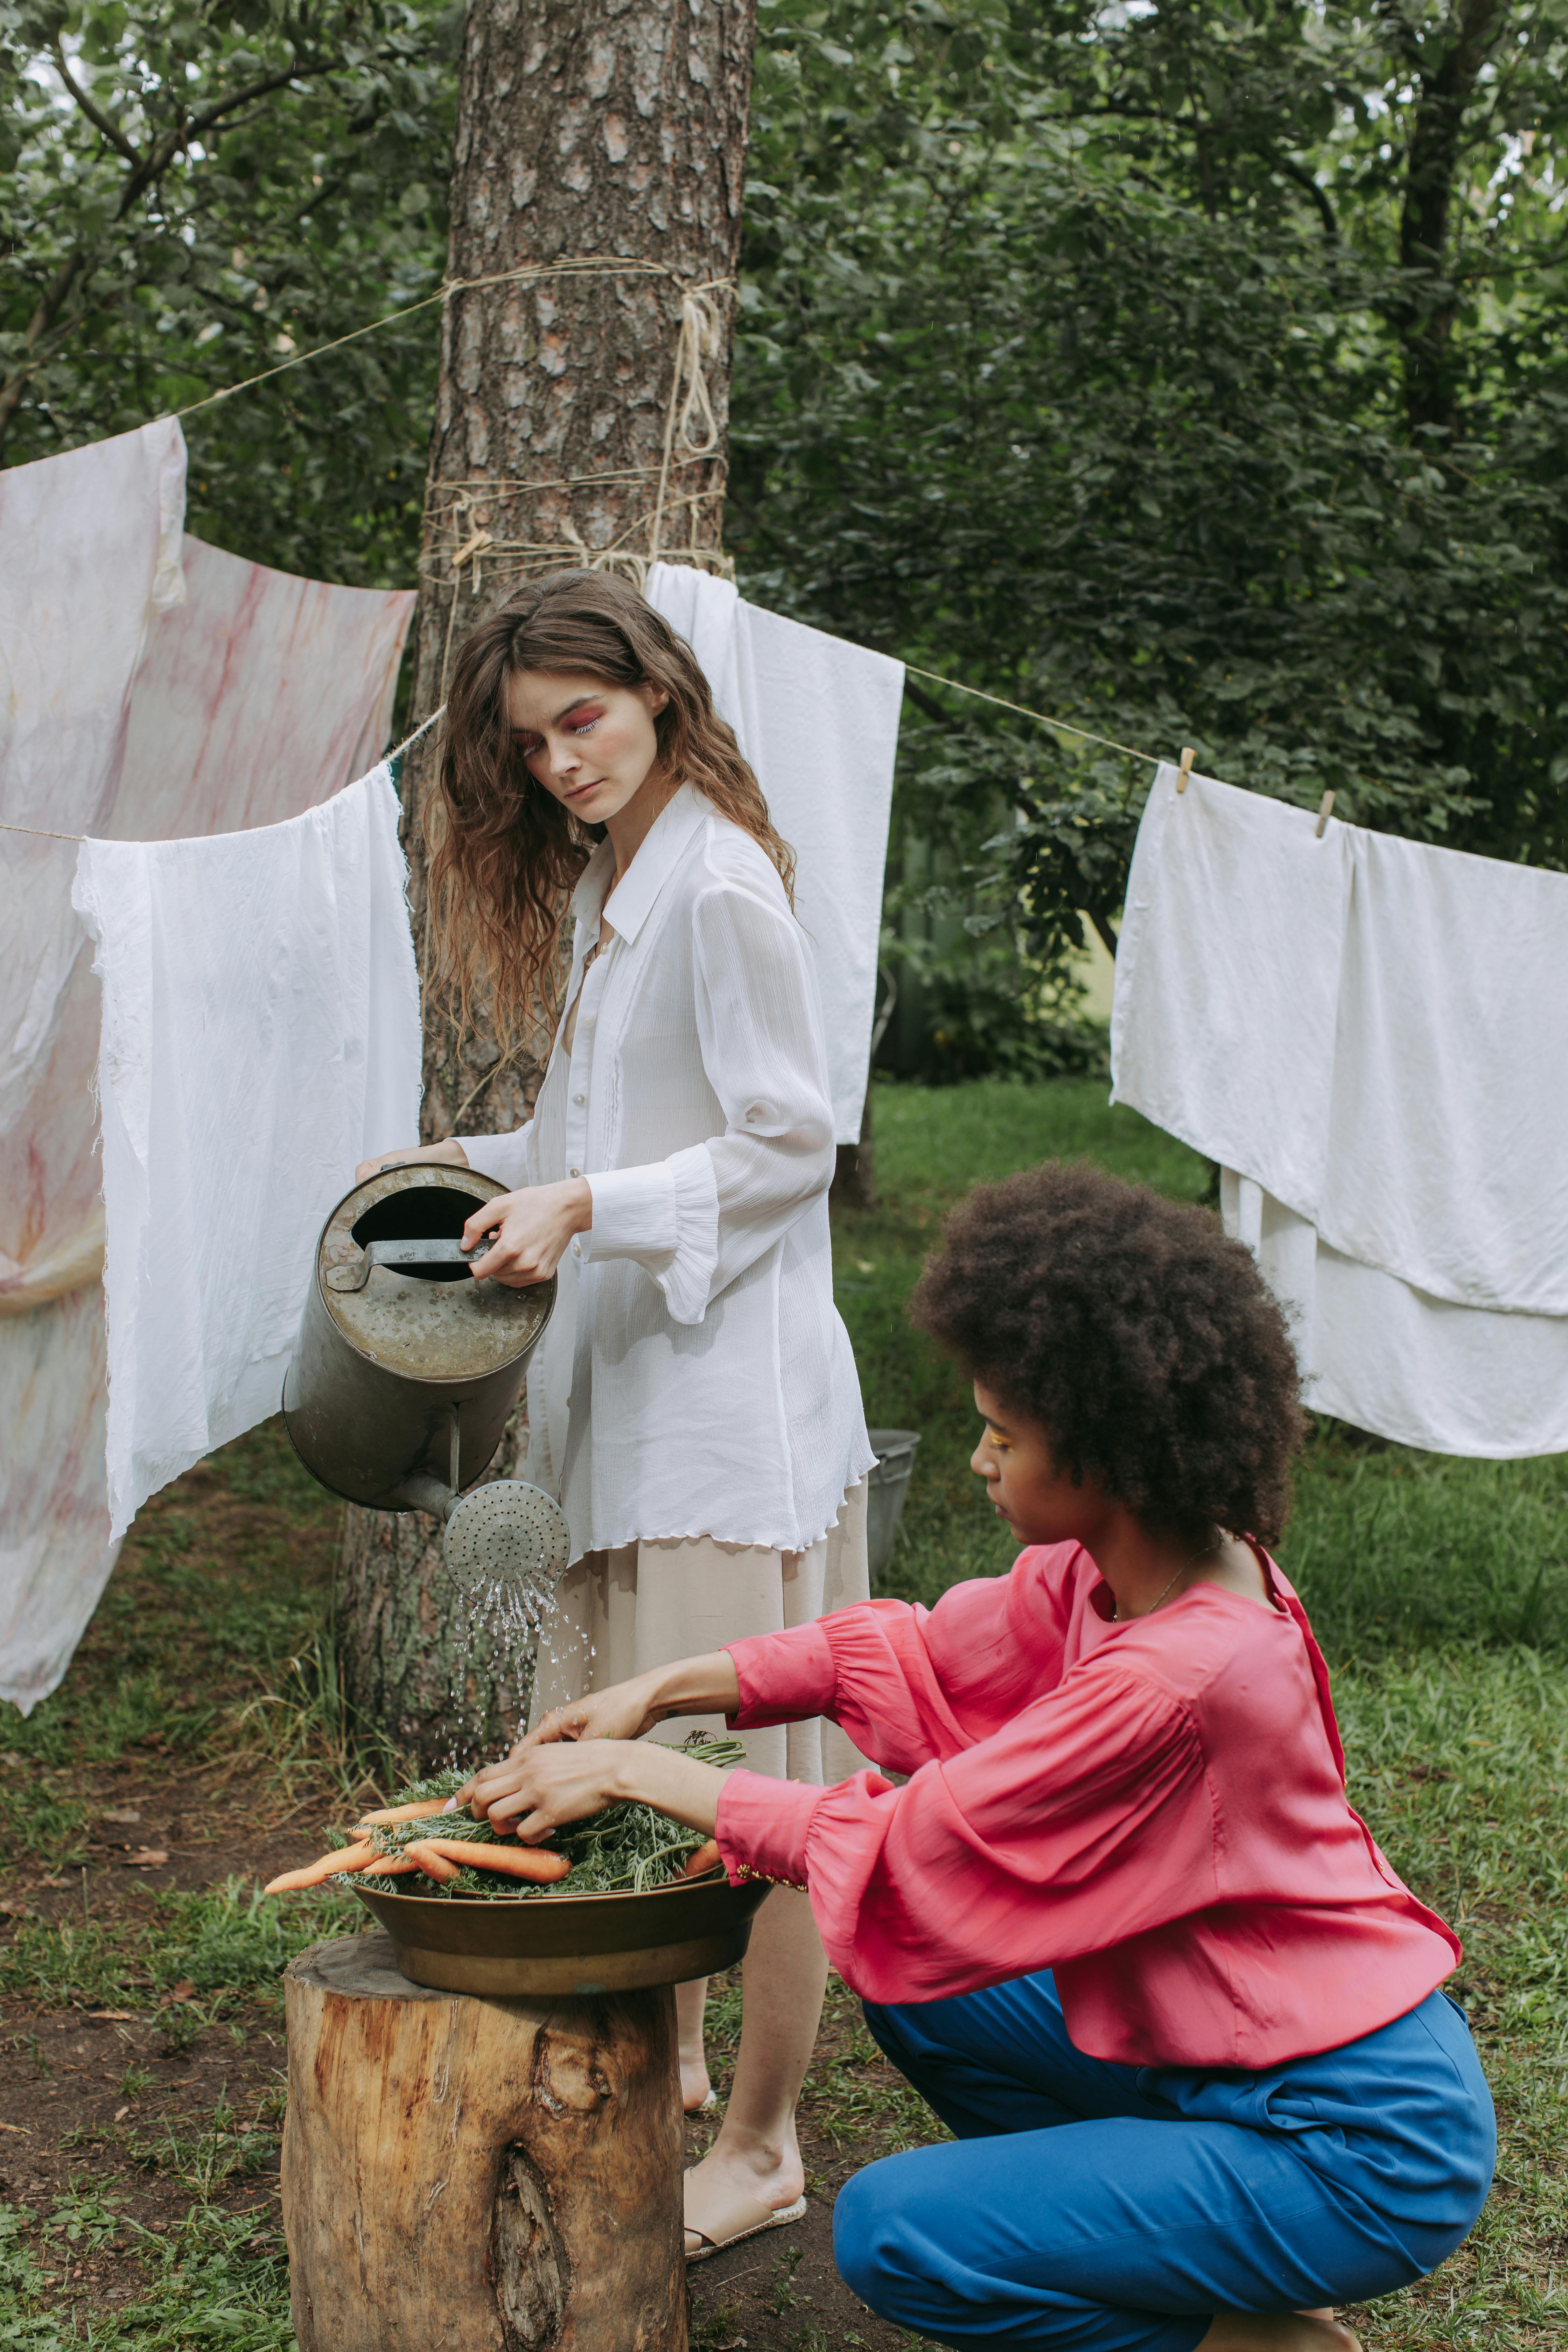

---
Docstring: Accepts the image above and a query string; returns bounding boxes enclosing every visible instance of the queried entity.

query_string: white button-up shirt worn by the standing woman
[461,785,875,1557]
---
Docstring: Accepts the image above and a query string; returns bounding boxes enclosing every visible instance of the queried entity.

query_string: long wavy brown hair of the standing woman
[426,572,794,1054]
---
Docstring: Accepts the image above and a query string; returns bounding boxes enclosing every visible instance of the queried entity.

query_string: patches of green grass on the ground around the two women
[0,1079,1568,2352]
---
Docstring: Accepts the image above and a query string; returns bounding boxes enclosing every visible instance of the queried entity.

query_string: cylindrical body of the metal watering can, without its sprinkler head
[282,1160,555,1515]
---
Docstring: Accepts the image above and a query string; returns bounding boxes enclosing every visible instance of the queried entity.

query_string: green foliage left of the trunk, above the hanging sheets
[0,0,461,586]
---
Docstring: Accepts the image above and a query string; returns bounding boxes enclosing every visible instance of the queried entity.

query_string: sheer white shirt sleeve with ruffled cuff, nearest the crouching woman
[583,880,834,1324]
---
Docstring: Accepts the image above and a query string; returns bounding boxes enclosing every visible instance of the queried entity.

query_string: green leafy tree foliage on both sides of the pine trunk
[0,0,1568,1061]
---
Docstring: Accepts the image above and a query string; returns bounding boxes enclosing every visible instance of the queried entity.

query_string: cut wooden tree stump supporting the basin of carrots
[282,1933,686,2352]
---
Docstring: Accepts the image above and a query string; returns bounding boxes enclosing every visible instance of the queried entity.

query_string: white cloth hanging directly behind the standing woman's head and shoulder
[644,565,903,1143]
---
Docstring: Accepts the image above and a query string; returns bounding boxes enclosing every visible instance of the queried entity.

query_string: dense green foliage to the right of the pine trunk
[729,0,1568,1040]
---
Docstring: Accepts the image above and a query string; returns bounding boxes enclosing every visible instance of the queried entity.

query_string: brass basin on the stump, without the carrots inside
[355,1872,769,1995]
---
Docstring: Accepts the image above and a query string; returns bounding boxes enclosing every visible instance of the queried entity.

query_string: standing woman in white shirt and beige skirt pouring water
[360,572,875,2258]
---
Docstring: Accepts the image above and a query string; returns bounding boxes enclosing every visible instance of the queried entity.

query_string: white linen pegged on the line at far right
[1112,767,1568,1458]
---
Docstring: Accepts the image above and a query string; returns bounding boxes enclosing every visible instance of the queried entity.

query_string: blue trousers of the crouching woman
[832,1971,1498,2352]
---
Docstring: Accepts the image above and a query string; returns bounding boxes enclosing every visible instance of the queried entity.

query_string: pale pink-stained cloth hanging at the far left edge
[0,419,186,1715]
